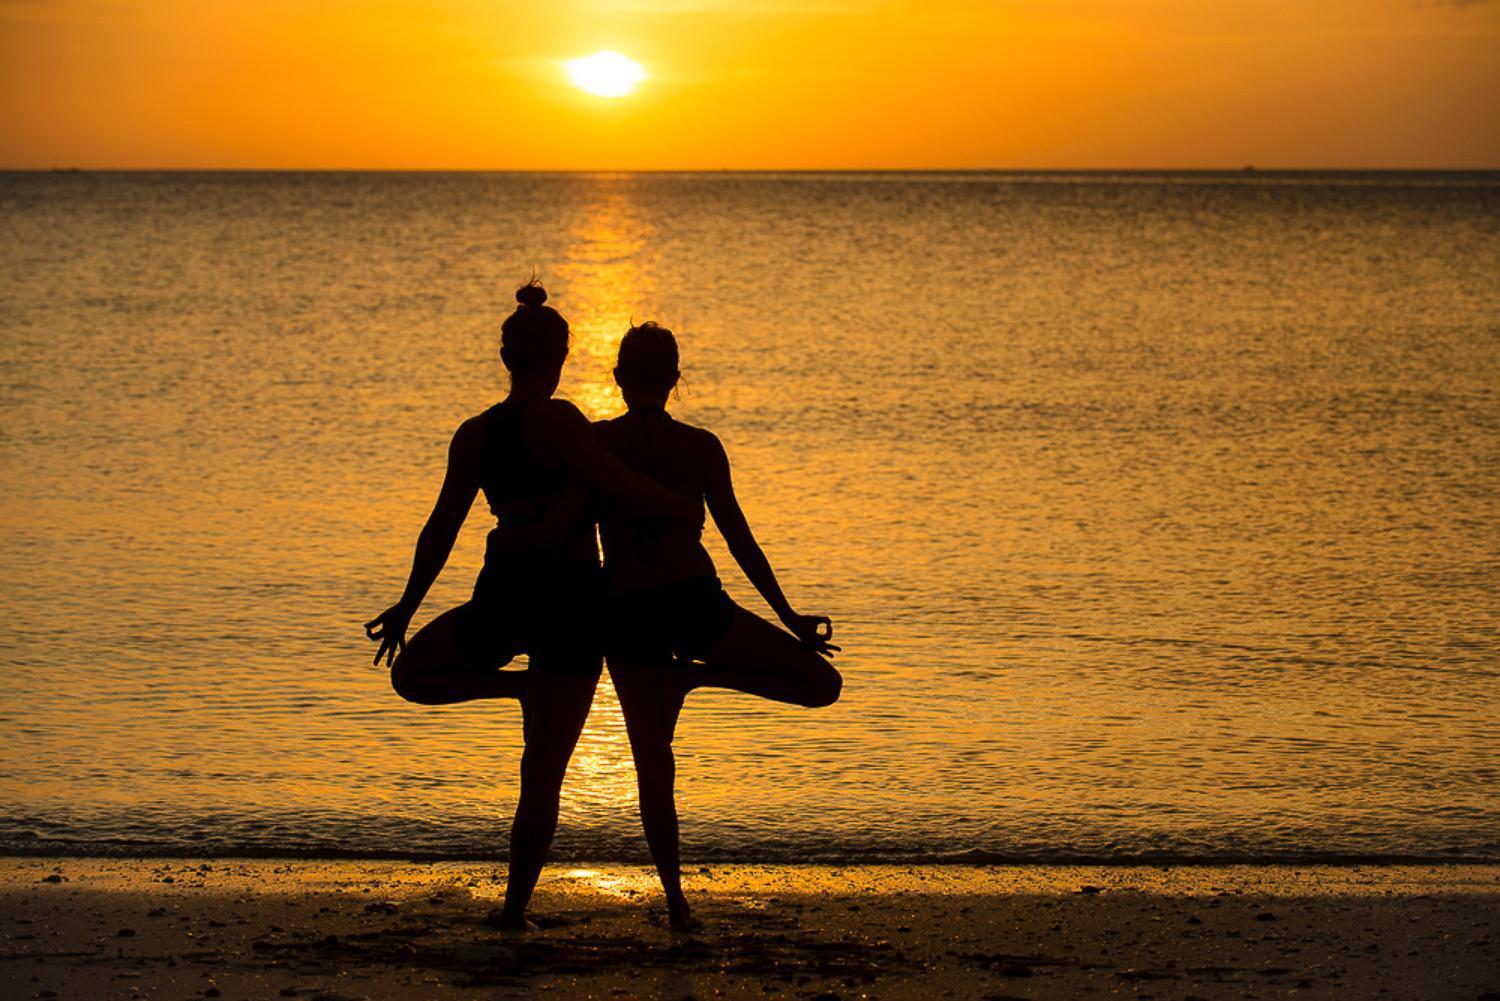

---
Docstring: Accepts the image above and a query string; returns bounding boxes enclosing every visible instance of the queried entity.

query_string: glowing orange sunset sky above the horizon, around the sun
[0,0,1500,170]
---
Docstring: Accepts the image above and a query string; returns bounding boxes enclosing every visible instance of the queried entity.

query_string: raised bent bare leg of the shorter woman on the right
[678,606,843,708]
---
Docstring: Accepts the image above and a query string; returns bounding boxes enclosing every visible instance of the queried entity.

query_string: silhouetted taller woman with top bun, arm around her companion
[365,281,699,929]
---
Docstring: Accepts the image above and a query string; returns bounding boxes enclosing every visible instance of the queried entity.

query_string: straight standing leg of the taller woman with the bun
[504,669,599,929]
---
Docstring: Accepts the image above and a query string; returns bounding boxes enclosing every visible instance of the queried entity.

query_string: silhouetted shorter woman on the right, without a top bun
[596,323,843,929]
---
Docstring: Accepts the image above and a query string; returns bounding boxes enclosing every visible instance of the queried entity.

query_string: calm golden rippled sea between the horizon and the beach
[0,174,1500,860]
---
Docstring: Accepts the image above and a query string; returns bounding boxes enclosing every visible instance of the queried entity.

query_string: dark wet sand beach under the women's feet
[0,858,1500,1001]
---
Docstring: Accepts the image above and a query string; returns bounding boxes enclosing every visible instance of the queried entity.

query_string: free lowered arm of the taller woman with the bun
[365,420,483,665]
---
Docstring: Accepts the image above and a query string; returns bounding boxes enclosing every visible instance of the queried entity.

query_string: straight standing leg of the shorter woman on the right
[609,659,695,930]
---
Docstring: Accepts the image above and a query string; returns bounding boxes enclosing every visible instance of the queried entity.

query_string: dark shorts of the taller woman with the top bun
[453,561,605,677]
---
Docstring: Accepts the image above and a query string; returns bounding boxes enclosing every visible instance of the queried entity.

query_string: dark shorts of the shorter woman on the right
[605,576,735,663]
